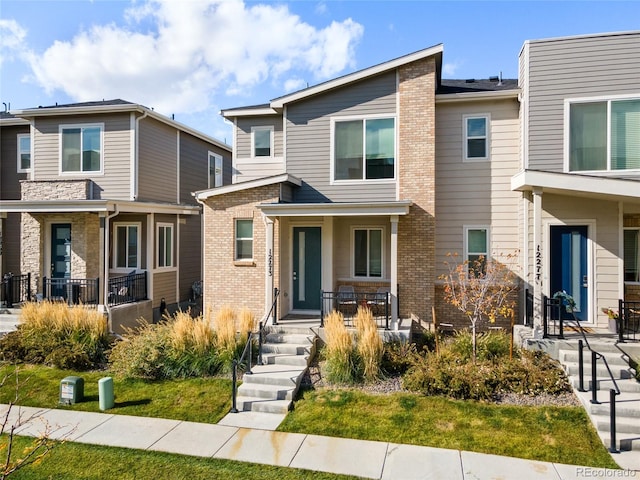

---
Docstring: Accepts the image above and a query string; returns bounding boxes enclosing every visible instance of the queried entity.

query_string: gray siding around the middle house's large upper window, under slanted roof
[286,72,401,202]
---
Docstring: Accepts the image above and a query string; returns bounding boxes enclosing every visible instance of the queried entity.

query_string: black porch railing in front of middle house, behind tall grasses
[320,291,391,330]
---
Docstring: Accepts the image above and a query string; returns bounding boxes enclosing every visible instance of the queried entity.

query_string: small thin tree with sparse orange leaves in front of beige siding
[439,252,518,363]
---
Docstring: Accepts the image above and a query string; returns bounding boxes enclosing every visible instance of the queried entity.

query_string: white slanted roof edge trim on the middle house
[271,43,444,109]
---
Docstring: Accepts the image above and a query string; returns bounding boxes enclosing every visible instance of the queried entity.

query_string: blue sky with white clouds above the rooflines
[0,0,640,143]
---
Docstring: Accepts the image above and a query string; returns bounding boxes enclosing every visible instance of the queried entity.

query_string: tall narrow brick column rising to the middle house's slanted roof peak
[398,58,436,320]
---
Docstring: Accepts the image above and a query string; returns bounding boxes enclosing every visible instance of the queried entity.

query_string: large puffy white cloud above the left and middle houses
[27,0,363,114]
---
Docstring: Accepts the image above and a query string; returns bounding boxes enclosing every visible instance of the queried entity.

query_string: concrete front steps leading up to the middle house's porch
[236,325,316,414]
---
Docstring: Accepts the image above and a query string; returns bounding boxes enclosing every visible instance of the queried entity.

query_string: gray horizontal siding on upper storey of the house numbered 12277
[525,33,640,171]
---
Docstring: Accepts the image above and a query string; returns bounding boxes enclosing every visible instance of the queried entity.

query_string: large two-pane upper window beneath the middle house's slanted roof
[333,118,396,180]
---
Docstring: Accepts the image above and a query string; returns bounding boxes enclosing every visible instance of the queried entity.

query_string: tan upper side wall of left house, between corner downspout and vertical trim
[137,118,178,203]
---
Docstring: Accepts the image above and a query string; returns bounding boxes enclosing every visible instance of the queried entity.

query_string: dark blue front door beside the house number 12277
[550,225,589,321]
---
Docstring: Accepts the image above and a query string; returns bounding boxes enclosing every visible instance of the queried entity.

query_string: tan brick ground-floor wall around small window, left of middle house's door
[203,184,280,319]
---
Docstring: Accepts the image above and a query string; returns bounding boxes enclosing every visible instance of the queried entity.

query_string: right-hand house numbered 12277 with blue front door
[512,31,640,326]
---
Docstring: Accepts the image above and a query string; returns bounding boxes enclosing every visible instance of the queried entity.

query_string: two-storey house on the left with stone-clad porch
[0,100,231,329]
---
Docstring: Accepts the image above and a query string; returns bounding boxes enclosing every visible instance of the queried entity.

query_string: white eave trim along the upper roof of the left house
[11,103,231,152]
